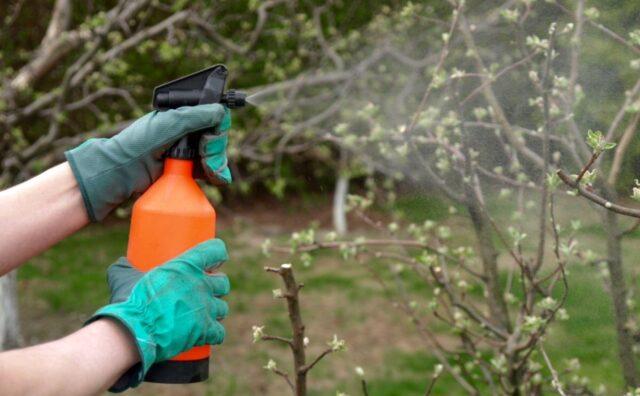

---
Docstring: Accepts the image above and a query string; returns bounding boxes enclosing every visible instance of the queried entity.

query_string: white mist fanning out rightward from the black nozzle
[247,5,632,207]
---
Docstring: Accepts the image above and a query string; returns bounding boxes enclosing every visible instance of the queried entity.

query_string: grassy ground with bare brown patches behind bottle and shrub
[13,191,638,396]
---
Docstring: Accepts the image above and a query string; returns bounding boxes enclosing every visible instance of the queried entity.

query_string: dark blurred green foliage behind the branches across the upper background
[0,0,639,192]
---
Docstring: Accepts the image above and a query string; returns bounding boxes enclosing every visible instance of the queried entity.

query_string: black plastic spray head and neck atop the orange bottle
[153,65,247,159]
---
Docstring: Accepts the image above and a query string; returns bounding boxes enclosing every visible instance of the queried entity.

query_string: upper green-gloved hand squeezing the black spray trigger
[65,104,231,222]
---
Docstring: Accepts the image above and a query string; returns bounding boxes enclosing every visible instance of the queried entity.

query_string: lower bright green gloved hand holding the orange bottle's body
[87,239,230,392]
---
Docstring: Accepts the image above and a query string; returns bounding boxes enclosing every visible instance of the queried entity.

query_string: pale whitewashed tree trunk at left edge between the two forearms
[0,271,22,351]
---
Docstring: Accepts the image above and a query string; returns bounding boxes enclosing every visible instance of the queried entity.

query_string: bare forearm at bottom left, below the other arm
[0,319,140,396]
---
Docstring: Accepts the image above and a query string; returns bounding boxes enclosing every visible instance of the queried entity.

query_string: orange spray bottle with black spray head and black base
[127,65,245,384]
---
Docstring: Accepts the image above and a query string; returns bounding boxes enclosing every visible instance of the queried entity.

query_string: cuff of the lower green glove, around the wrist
[84,302,157,393]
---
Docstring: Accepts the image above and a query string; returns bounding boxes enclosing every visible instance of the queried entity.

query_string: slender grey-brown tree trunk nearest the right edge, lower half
[604,207,639,388]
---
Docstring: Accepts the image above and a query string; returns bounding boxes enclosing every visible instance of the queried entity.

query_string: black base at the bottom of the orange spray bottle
[144,358,209,384]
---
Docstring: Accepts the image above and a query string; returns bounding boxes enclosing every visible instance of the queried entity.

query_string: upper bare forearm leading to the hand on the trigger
[0,162,89,275]
